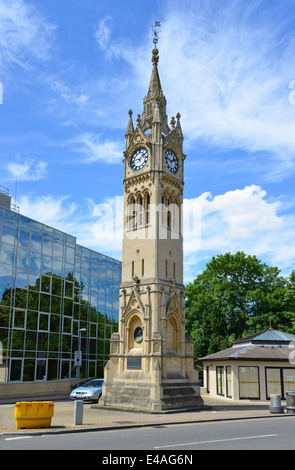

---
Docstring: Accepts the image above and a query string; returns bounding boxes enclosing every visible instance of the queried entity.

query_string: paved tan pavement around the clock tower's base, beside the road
[0,394,294,436]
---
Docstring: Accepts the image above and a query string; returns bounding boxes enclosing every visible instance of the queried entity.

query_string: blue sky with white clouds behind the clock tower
[0,0,295,283]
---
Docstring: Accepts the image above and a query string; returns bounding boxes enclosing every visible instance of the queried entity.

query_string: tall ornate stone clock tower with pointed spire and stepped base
[99,29,203,413]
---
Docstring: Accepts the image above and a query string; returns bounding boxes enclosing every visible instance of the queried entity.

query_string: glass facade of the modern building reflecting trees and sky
[0,207,121,382]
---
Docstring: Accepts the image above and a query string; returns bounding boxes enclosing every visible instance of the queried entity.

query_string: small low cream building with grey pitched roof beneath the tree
[200,328,295,401]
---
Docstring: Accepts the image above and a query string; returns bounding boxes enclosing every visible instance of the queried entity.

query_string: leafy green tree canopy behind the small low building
[186,252,295,366]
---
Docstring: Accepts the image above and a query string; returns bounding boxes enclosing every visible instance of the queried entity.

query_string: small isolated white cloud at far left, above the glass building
[7,156,47,181]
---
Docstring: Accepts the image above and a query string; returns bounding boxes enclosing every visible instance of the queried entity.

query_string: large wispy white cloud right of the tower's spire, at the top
[134,0,295,179]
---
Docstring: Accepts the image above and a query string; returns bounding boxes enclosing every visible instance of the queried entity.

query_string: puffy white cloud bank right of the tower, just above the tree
[184,185,295,281]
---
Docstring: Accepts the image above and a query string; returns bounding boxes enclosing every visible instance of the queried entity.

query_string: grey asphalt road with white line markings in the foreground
[0,415,295,454]
